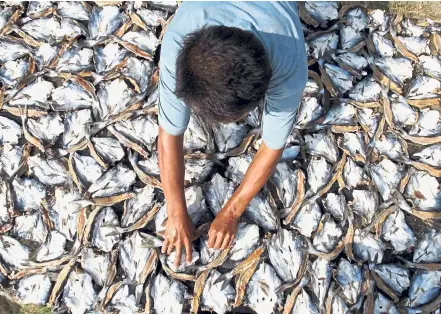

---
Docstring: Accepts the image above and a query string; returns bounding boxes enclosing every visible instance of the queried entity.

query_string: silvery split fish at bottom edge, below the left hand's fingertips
[151,273,187,314]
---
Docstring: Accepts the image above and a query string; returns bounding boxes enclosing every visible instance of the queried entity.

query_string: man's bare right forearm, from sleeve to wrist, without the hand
[226,143,283,218]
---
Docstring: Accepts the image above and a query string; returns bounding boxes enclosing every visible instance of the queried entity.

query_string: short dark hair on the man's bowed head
[175,26,271,123]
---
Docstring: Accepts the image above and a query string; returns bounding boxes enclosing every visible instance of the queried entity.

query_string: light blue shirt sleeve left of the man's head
[158,32,190,136]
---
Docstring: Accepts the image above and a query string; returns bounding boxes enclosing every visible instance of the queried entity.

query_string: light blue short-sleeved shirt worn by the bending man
[159,2,308,149]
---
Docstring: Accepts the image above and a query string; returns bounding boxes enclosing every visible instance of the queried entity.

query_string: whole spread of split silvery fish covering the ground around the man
[0,1,441,314]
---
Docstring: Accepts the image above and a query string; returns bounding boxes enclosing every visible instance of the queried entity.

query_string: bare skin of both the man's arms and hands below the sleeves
[158,127,283,266]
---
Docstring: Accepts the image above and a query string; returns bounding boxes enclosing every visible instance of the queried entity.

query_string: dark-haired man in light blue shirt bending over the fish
[158,2,307,265]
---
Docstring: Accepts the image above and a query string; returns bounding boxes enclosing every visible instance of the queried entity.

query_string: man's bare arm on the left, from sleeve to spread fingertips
[158,127,194,266]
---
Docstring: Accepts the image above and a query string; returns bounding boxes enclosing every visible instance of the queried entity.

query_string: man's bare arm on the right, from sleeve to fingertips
[208,142,283,249]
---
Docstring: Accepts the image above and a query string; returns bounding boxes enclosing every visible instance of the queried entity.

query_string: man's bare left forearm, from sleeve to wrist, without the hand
[158,127,187,217]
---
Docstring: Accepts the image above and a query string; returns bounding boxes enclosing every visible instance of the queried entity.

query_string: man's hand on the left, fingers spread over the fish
[161,213,194,266]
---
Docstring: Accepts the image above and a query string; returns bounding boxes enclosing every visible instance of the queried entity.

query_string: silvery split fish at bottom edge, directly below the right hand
[201,269,235,314]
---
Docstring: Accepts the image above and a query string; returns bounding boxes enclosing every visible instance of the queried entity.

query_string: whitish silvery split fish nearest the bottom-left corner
[17,274,52,305]
